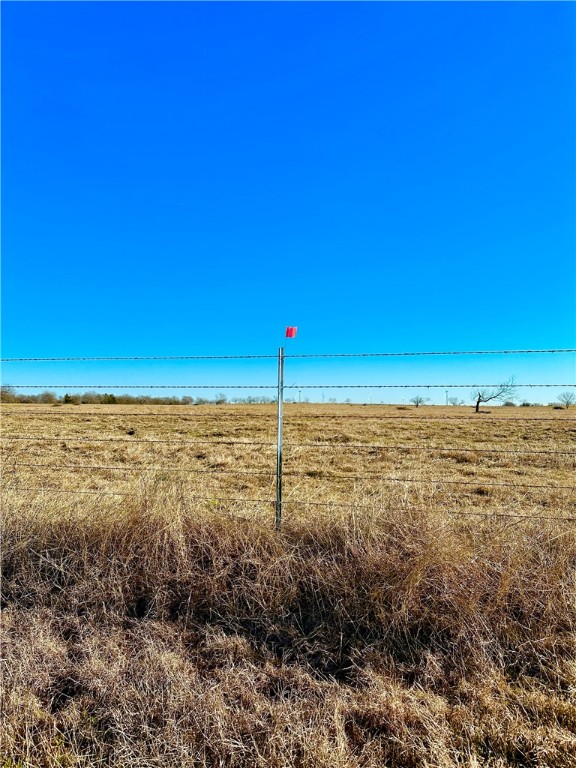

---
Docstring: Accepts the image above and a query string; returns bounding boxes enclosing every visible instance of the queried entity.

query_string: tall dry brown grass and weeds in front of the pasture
[2,488,576,768]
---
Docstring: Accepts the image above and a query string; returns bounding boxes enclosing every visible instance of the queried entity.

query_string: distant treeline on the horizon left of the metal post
[0,386,276,405]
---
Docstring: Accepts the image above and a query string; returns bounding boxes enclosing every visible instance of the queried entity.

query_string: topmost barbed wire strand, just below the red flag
[0,349,576,363]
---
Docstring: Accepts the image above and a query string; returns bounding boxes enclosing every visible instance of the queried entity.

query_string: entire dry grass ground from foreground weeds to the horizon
[0,404,576,768]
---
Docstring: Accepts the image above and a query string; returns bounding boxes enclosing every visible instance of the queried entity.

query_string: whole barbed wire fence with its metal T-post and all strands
[1,348,576,530]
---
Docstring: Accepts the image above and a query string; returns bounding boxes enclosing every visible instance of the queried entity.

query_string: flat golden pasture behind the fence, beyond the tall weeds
[3,405,576,522]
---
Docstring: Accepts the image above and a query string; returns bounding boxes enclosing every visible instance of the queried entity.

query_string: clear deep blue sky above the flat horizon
[2,2,576,402]
